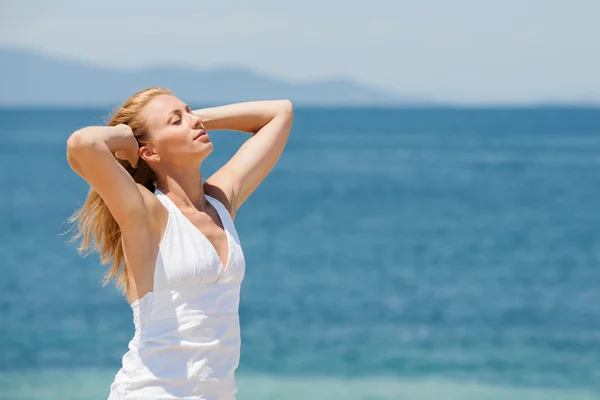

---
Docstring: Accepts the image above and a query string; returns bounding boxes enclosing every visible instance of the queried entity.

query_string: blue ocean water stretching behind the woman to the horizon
[0,108,600,400]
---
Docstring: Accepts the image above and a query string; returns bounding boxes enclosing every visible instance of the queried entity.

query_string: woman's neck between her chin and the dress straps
[156,166,207,211]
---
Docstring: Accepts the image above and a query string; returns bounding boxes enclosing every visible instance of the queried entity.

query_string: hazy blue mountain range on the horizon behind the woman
[0,49,406,107]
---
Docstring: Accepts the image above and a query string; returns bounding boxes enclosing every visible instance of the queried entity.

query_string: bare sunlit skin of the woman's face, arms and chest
[67,94,293,301]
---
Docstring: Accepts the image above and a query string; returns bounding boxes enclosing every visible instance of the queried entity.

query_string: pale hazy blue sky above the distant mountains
[0,0,600,103]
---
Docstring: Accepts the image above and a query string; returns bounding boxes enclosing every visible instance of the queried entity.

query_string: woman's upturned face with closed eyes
[141,94,213,165]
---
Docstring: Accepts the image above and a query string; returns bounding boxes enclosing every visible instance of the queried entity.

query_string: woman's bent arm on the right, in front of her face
[194,100,293,216]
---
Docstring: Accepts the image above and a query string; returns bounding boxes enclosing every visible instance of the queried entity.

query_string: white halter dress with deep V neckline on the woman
[109,190,246,400]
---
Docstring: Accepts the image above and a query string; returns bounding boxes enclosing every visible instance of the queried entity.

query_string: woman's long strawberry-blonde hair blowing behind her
[69,87,172,295]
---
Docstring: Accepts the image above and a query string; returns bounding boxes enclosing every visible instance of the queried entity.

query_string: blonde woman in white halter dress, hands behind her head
[67,88,293,400]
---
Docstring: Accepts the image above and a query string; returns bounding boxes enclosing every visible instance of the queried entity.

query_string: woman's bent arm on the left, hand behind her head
[67,125,145,228]
